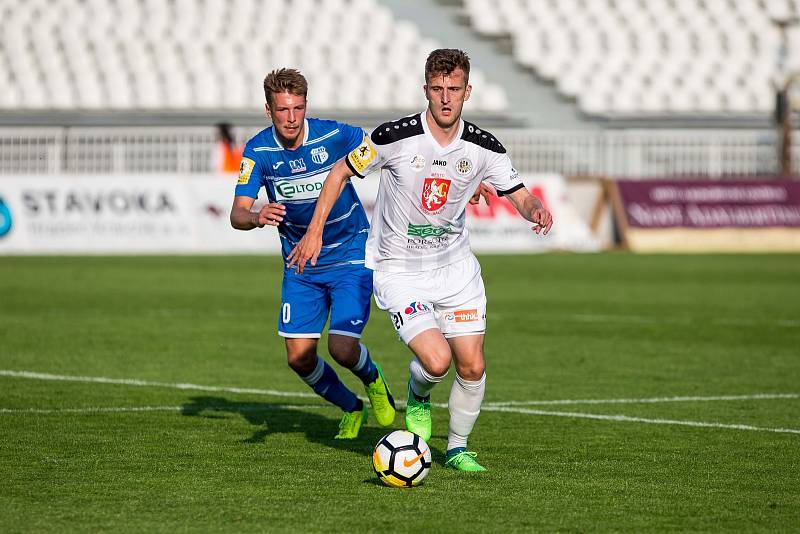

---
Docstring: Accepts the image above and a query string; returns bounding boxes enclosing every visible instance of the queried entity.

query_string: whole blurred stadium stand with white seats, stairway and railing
[0,0,800,177]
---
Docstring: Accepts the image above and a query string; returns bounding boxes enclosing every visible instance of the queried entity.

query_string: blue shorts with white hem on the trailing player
[278,264,372,338]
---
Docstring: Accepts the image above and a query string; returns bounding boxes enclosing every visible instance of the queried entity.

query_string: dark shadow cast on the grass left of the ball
[181,397,443,462]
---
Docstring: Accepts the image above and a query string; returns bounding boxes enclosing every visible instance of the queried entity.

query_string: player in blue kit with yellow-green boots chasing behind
[230,69,395,439]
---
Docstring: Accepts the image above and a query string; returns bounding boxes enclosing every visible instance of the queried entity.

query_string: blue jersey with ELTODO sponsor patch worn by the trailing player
[236,119,369,271]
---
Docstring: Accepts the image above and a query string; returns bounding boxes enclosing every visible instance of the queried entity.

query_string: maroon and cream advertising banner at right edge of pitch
[614,178,800,252]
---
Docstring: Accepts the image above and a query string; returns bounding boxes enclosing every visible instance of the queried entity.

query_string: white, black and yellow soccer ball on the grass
[372,430,431,488]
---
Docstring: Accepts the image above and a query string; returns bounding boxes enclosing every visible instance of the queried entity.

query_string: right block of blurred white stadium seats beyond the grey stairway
[464,0,800,116]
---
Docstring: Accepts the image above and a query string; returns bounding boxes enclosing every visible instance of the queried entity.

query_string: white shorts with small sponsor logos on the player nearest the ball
[372,256,486,344]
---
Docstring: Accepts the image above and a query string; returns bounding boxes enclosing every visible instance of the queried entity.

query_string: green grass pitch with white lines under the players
[0,253,800,533]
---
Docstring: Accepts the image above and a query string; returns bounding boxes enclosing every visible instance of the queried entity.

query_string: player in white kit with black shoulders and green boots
[288,49,553,471]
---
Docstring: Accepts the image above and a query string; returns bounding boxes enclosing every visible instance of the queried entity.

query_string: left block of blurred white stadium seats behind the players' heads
[0,0,508,111]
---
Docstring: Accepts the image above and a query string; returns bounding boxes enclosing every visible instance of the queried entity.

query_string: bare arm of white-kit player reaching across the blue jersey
[286,159,353,273]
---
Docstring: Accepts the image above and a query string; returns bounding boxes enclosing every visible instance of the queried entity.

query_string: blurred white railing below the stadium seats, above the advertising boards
[0,127,800,178]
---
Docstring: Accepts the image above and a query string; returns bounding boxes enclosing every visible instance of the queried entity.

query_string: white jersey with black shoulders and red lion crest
[346,112,524,272]
